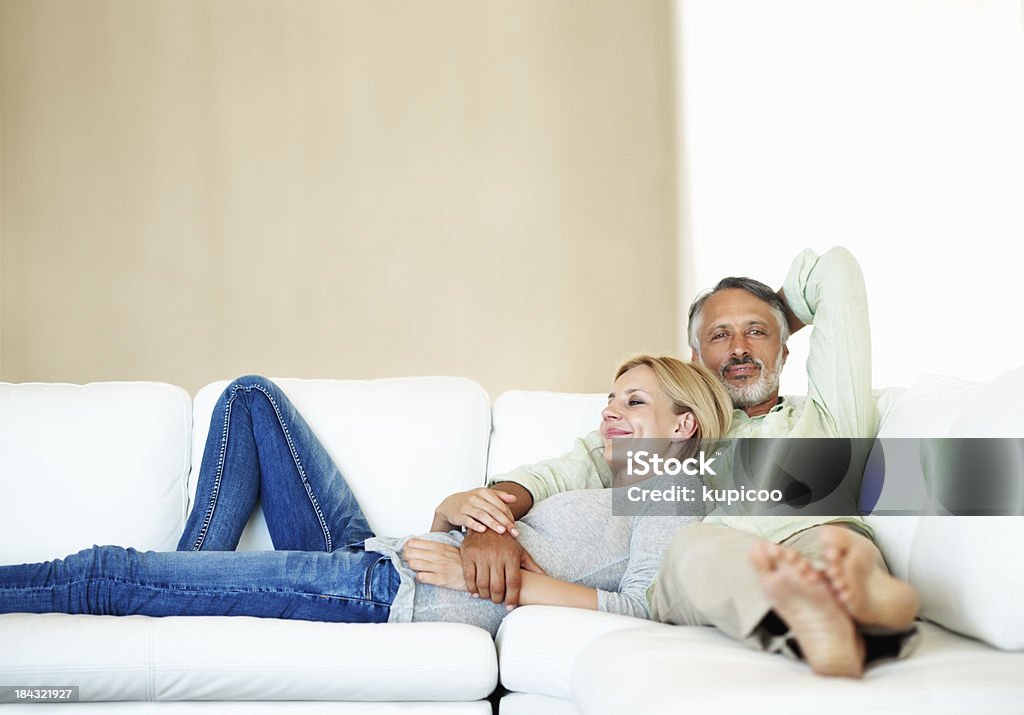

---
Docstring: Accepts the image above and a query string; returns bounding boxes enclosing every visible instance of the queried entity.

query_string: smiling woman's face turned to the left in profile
[601,365,696,462]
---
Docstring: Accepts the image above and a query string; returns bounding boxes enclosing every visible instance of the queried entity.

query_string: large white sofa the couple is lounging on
[0,370,1024,715]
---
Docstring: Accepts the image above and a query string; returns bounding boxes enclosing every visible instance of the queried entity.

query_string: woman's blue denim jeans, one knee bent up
[0,376,399,623]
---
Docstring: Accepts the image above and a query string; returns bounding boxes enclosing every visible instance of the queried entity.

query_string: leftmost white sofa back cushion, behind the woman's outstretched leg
[0,382,191,563]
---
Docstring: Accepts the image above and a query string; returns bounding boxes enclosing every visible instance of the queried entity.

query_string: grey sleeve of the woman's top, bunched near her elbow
[597,516,700,619]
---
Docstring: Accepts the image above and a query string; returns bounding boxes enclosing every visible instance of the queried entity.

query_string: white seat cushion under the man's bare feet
[572,624,1024,715]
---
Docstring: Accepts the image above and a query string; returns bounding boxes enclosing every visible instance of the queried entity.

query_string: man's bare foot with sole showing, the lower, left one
[751,542,864,678]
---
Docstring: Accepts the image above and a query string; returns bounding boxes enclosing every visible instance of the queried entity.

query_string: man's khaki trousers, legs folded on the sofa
[650,523,916,660]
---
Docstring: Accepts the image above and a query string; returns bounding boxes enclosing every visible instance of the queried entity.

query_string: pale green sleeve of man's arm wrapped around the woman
[487,431,613,504]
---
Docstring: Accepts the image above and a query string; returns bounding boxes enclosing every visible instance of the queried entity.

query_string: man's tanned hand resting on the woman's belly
[461,531,544,605]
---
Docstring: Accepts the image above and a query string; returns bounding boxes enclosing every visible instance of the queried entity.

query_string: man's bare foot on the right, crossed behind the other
[820,527,919,628]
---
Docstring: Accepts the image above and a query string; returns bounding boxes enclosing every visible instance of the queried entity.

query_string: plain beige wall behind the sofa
[0,0,679,394]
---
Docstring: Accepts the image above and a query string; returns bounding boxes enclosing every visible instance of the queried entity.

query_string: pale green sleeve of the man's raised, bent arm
[782,247,879,437]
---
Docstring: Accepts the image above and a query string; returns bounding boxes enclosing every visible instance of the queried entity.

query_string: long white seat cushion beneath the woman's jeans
[0,614,498,701]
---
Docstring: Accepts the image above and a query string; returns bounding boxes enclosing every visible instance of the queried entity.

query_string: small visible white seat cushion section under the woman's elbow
[495,605,657,698]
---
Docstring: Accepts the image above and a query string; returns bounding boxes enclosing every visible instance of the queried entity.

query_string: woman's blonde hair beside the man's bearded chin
[614,354,732,441]
